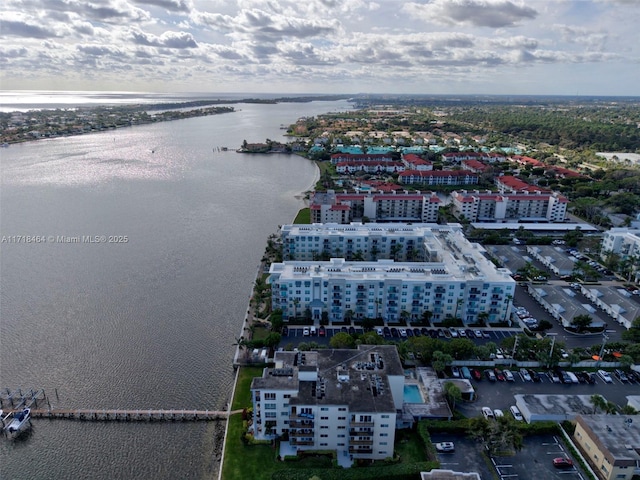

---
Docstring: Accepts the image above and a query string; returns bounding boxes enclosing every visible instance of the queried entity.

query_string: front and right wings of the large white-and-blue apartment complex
[269,226,515,324]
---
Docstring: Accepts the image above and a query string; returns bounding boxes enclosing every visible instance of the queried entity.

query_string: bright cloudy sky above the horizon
[0,0,640,96]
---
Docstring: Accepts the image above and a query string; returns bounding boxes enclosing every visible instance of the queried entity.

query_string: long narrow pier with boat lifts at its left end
[0,388,241,429]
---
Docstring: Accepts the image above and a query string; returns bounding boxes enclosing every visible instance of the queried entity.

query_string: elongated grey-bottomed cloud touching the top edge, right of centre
[402,0,537,28]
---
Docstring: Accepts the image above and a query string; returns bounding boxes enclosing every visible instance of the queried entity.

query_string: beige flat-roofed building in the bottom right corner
[573,415,640,480]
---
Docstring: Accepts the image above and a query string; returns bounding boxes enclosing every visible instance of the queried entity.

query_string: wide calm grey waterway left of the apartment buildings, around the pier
[0,98,350,479]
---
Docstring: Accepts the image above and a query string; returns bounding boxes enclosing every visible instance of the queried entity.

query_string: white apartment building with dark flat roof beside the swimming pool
[251,345,404,460]
